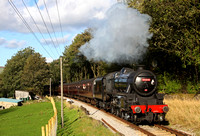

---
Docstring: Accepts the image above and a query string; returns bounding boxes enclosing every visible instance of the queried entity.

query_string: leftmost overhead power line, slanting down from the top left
[8,0,53,59]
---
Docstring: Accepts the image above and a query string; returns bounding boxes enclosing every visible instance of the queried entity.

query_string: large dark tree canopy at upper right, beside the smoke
[129,0,200,82]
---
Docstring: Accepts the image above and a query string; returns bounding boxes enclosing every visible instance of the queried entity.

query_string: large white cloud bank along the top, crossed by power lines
[0,0,116,33]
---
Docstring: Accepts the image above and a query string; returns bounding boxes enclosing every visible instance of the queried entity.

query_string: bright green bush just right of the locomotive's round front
[158,72,182,94]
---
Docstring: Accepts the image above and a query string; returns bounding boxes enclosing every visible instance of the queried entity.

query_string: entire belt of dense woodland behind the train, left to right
[0,0,200,97]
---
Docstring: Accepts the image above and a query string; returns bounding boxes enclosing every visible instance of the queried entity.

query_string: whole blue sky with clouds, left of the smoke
[0,0,117,66]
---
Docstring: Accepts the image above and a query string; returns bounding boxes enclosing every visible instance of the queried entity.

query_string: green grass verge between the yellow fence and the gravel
[56,99,117,136]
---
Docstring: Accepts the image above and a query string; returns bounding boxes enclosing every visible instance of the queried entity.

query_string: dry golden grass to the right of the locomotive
[165,95,200,136]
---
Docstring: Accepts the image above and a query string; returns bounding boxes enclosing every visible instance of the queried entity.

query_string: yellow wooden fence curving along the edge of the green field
[41,96,58,136]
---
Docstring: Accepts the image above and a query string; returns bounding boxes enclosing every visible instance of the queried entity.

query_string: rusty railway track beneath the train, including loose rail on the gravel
[66,96,191,136]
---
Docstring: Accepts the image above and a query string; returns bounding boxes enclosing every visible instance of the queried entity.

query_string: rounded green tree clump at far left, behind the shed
[1,47,48,97]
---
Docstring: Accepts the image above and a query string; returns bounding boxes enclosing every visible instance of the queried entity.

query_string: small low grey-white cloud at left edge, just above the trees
[0,37,26,49]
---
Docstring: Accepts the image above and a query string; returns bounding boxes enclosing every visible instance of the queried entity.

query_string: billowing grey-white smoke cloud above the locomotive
[79,4,153,63]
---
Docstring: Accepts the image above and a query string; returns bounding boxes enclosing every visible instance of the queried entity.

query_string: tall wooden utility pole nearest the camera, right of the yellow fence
[60,57,64,128]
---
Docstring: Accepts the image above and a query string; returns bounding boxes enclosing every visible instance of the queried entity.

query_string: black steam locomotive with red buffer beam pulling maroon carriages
[59,67,169,123]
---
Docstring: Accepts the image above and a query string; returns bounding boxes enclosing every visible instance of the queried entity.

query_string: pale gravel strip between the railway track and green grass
[66,98,143,136]
